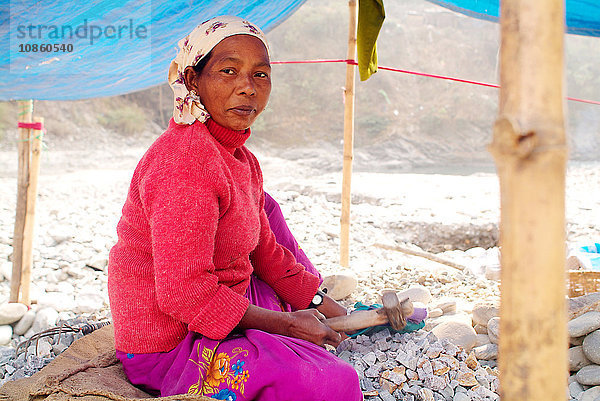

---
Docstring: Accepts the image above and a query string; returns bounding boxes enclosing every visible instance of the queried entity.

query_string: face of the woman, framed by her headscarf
[192,35,271,130]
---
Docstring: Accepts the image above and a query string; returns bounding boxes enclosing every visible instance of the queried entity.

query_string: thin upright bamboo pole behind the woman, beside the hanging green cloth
[340,0,358,267]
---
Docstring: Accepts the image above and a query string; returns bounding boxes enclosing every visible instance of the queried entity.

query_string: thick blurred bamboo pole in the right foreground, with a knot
[490,0,568,401]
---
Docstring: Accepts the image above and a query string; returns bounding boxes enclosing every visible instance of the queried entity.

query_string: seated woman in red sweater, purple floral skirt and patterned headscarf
[108,17,362,401]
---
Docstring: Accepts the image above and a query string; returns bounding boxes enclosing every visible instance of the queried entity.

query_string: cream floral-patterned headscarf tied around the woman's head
[169,15,269,124]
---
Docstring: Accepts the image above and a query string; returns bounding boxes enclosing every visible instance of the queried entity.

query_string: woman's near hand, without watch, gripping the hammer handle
[285,309,342,347]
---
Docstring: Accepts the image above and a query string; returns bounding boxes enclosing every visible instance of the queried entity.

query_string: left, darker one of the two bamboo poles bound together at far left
[9,100,33,302]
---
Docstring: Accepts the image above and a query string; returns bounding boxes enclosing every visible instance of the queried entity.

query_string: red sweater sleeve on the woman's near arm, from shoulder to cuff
[140,146,249,339]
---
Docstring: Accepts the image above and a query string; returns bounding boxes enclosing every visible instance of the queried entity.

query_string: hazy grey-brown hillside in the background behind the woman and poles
[0,0,600,171]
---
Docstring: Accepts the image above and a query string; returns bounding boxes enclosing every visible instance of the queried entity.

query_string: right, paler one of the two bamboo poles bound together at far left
[19,117,44,305]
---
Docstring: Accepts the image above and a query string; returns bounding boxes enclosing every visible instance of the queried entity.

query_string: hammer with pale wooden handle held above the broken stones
[322,291,414,332]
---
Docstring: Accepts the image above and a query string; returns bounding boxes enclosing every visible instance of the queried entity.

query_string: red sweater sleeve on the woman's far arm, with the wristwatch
[251,192,320,309]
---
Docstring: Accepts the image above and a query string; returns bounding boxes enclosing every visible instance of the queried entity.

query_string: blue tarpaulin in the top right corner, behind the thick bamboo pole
[428,0,600,36]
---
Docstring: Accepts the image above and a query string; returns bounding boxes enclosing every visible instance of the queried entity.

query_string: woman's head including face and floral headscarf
[169,16,271,129]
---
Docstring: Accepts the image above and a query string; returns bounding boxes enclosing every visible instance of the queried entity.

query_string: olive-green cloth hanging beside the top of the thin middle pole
[356,0,385,81]
